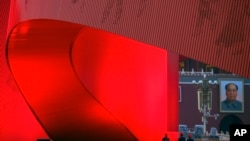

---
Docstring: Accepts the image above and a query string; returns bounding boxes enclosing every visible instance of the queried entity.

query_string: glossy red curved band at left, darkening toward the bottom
[7,20,136,141]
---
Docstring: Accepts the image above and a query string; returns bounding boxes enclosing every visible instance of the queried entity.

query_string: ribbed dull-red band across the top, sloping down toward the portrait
[7,0,250,78]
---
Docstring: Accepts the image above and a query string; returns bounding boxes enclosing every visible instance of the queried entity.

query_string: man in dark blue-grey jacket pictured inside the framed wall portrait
[221,83,242,111]
